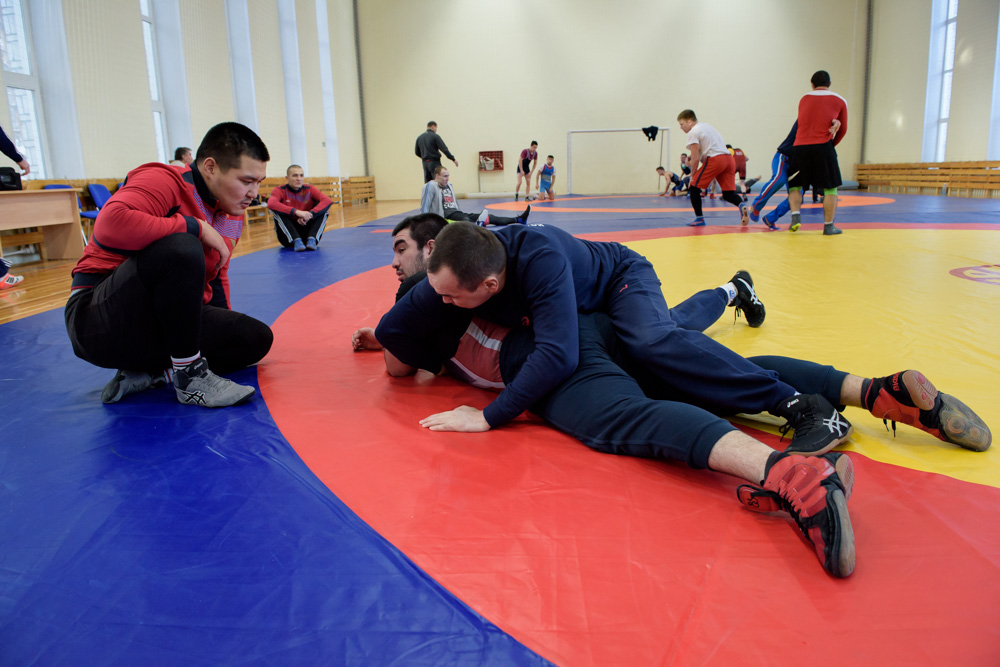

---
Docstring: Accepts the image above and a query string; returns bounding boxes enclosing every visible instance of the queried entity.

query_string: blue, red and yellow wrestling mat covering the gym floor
[0,192,1000,665]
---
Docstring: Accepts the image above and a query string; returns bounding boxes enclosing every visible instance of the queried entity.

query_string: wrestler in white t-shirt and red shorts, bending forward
[677,109,750,227]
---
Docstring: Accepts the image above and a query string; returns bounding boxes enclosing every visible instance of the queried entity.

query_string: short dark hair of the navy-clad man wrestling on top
[427,222,507,290]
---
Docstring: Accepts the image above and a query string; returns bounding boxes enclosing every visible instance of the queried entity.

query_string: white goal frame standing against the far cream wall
[572,125,680,195]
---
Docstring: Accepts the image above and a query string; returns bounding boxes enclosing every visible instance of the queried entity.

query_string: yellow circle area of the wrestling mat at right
[627,228,1000,487]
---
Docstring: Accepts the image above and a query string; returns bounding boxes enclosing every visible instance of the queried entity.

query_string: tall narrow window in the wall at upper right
[921,0,958,162]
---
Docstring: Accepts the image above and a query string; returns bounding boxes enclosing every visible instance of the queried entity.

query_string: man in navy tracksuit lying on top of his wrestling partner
[376,223,852,454]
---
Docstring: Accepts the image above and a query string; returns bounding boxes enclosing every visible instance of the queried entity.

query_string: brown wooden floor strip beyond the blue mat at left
[0,200,420,324]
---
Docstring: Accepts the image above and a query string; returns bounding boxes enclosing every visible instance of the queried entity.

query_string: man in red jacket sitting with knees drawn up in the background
[267,164,333,252]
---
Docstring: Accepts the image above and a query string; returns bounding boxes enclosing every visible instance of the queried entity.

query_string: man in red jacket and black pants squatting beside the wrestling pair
[65,123,273,408]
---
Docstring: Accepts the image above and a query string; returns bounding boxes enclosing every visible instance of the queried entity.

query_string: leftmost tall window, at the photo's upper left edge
[0,0,46,178]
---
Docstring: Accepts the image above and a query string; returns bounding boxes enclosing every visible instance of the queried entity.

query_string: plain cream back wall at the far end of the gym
[359,0,867,199]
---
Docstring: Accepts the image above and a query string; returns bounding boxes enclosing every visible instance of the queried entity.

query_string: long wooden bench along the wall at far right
[855,161,1000,199]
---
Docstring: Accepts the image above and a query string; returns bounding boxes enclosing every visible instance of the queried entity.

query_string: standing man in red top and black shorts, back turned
[788,70,847,236]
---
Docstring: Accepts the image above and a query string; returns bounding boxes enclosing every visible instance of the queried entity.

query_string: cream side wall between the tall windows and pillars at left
[42,0,364,178]
